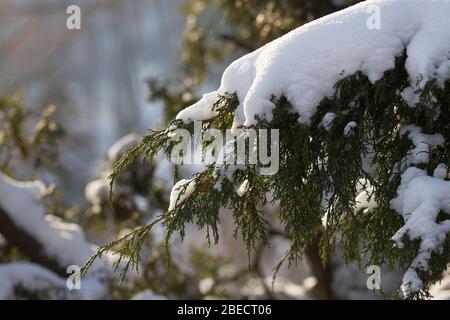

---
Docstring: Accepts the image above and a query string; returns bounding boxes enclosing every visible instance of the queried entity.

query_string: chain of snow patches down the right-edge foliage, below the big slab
[391,125,450,296]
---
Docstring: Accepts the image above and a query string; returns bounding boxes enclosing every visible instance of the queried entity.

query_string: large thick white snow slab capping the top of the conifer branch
[177,0,450,127]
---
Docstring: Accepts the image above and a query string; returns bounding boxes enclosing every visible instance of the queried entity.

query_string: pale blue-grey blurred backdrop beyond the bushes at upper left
[0,0,185,201]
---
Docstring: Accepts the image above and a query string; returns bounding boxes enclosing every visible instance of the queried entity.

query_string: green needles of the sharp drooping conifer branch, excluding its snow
[86,54,450,298]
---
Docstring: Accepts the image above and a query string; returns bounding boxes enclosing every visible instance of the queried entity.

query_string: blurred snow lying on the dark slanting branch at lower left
[0,175,113,299]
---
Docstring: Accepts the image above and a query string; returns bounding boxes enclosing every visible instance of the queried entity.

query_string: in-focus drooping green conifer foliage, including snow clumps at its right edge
[87,0,450,298]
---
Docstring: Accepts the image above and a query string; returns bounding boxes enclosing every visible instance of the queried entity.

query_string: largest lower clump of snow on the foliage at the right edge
[391,166,450,296]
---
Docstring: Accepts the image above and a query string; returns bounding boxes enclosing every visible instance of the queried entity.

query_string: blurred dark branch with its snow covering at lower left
[0,175,112,298]
